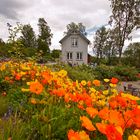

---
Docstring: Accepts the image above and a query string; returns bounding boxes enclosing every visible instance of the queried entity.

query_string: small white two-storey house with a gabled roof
[59,31,90,65]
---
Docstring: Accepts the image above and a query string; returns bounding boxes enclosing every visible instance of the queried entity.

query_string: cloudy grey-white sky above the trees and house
[0,0,140,54]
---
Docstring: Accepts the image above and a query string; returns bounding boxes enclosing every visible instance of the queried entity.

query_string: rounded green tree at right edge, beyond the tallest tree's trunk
[123,42,140,68]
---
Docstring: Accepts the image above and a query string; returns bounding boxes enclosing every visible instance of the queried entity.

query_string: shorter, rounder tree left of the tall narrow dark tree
[20,24,36,48]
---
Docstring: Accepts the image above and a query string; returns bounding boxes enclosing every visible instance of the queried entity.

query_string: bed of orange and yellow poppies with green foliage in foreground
[0,61,140,140]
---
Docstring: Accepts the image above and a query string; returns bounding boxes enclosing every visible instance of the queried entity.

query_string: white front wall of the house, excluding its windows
[61,35,88,65]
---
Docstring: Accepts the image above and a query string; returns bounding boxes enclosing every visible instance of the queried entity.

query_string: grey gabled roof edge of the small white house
[59,31,90,44]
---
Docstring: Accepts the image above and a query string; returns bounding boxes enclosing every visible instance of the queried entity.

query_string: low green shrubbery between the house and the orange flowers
[53,64,139,81]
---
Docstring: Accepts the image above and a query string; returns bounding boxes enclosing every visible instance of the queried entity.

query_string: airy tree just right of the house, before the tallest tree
[93,26,117,64]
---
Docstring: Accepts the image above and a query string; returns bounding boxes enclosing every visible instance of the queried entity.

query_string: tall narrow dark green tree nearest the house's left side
[37,18,52,55]
